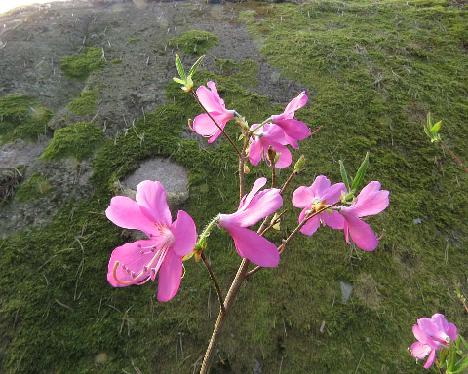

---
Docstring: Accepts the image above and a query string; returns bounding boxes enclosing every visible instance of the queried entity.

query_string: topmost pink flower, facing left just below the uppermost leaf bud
[192,81,235,143]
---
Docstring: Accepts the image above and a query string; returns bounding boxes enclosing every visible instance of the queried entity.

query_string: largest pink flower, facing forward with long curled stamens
[106,180,197,301]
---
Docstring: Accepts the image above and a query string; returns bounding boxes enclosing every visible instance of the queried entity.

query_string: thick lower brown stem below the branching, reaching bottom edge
[200,259,250,374]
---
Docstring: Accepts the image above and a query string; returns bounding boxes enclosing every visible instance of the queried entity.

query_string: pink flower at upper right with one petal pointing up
[271,91,311,148]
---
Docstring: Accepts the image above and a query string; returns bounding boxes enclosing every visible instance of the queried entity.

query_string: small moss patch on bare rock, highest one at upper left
[60,47,104,79]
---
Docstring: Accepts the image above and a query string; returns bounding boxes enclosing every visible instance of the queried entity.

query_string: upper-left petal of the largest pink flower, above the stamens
[106,196,156,236]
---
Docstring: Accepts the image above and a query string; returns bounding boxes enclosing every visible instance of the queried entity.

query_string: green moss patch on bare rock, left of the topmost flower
[41,122,104,161]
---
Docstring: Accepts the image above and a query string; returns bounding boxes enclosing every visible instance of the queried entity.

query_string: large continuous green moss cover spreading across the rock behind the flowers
[0,1,468,373]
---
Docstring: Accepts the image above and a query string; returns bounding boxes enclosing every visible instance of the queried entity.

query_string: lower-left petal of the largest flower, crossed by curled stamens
[107,240,154,287]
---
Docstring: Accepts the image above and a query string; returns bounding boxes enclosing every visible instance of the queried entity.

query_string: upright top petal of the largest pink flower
[136,180,172,226]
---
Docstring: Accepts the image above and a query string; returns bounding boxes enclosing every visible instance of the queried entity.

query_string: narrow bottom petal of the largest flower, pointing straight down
[158,251,182,302]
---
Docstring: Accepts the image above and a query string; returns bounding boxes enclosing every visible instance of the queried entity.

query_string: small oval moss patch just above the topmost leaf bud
[169,30,218,55]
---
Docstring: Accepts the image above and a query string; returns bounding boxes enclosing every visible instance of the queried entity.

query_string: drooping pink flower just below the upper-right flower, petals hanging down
[249,123,292,169]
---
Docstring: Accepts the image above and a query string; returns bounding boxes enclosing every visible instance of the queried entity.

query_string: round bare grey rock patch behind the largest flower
[121,158,189,208]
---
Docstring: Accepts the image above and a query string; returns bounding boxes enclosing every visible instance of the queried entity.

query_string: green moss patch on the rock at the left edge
[0,94,52,144]
